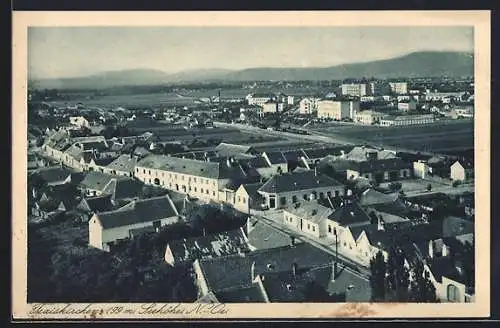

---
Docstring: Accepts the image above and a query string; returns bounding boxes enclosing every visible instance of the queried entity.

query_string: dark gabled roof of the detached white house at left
[97,196,178,229]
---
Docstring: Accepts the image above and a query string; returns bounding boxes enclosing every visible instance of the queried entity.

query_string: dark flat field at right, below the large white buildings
[314,121,474,153]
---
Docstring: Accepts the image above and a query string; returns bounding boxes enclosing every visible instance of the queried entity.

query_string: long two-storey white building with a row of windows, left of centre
[135,155,254,202]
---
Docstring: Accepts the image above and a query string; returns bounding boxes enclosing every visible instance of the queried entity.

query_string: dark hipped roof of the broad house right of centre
[259,171,341,193]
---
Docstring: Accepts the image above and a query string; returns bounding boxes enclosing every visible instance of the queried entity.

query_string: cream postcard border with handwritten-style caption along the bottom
[12,11,491,320]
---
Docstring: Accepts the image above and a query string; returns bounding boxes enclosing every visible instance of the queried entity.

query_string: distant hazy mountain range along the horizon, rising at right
[30,51,474,89]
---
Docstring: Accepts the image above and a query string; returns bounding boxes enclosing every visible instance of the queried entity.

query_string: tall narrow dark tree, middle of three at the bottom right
[387,247,410,301]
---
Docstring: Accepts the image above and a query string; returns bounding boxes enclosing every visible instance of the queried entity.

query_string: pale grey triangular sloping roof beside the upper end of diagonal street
[244,216,302,251]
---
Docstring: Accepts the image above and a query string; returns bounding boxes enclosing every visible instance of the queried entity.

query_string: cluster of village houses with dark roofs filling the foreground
[29,124,474,302]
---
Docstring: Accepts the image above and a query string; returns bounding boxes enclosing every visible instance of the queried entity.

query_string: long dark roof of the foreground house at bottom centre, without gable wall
[199,243,332,291]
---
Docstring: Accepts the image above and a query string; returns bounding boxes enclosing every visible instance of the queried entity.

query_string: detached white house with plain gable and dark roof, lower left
[88,195,179,251]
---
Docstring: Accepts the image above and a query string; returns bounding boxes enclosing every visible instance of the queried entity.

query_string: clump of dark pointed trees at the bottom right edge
[370,248,438,302]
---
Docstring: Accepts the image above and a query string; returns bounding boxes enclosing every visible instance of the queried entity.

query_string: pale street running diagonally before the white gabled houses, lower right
[250,210,370,279]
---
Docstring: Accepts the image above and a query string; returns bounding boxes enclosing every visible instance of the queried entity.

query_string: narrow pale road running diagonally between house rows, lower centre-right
[250,210,371,279]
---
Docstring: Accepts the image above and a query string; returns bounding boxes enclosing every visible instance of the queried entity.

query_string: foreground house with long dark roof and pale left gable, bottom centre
[193,243,332,299]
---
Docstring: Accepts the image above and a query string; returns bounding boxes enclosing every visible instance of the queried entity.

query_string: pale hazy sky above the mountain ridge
[28,27,473,78]
